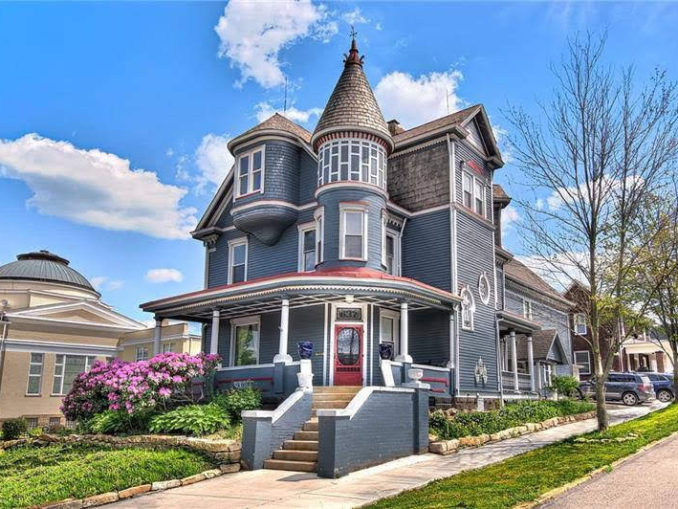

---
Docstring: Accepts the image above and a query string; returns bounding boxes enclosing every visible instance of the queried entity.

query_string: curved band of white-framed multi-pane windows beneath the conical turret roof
[318,139,386,189]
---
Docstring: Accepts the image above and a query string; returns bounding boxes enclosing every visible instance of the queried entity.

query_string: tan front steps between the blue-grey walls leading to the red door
[264,386,362,472]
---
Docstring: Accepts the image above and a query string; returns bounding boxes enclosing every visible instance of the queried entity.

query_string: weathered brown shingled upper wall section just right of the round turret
[388,138,450,212]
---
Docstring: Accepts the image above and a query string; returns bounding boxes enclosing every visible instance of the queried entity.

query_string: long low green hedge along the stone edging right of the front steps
[429,399,595,440]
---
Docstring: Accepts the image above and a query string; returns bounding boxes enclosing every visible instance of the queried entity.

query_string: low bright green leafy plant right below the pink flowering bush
[149,403,229,436]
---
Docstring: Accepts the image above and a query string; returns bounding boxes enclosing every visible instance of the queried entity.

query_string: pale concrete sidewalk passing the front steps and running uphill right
[114,403,663,509]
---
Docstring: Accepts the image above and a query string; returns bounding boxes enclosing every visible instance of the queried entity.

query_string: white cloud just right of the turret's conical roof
[374,70,463,129]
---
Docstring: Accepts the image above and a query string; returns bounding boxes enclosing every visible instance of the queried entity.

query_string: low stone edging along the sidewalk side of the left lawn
[39,463,240,509]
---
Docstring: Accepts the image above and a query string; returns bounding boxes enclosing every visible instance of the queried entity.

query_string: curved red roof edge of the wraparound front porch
[141,267,458,308]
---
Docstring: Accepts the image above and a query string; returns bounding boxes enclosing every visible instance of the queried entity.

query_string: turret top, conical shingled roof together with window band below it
[311,38,394,191]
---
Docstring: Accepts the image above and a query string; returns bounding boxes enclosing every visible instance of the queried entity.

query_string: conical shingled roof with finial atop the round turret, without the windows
[312,39,393,150]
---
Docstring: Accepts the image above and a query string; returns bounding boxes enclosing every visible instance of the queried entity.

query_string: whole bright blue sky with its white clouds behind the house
[0,0,678,320]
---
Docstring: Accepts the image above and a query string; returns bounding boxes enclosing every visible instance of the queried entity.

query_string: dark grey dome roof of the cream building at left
[0,250,96,293]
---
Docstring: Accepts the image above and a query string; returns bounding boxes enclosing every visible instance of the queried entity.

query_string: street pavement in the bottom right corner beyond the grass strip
[540,426,678,509]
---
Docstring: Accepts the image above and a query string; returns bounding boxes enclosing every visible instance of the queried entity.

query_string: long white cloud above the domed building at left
[0,134,196,239]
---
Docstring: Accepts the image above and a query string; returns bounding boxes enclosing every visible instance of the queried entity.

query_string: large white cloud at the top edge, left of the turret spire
[214,0,338,88]
